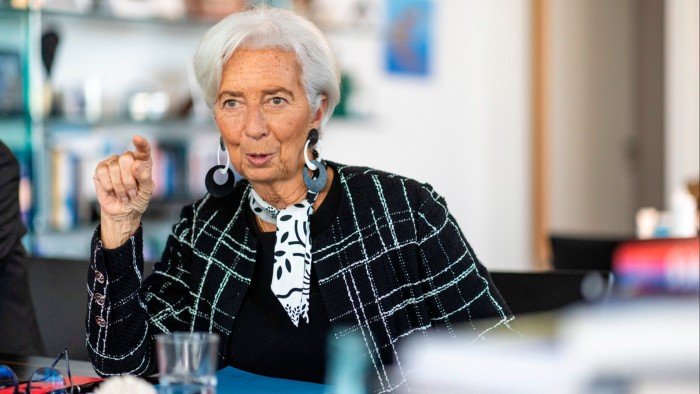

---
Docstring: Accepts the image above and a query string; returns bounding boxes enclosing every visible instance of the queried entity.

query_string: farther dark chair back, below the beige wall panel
[550,235,629,271]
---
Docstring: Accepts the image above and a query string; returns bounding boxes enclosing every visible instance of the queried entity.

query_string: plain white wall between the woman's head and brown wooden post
[322,0,531,269]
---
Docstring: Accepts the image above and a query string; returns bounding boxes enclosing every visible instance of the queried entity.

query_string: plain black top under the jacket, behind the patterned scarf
[226,168,341,383]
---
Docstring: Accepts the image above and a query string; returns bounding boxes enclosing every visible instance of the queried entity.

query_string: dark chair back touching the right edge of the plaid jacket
[491,270,611,316]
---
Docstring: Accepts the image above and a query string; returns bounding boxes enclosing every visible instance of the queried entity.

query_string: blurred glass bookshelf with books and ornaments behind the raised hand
[0,4,217,260]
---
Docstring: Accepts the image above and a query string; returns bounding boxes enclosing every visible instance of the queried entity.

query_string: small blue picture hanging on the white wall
[385,0,433,76]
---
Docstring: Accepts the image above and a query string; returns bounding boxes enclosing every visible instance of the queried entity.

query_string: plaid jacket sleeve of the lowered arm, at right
[415,184,513,336]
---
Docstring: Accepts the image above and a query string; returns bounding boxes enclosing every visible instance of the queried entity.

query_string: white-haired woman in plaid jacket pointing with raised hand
[87,9,512,391]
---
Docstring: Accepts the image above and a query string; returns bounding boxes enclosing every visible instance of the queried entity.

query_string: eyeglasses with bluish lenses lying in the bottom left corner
[0,349,79,394]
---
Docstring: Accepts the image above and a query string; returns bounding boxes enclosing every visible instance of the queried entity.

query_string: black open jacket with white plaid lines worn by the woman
[86,163,512,392]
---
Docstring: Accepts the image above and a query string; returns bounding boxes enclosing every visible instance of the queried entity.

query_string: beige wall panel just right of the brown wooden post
[549,0,635,235]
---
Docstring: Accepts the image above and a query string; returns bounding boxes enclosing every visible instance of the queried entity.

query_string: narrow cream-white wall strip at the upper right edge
[665,0,700,203]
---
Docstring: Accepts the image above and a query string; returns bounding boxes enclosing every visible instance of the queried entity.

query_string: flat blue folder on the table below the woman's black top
[216,367,331,394]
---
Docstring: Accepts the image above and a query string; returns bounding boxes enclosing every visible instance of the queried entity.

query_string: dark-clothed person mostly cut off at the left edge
[0,141,44,355]
